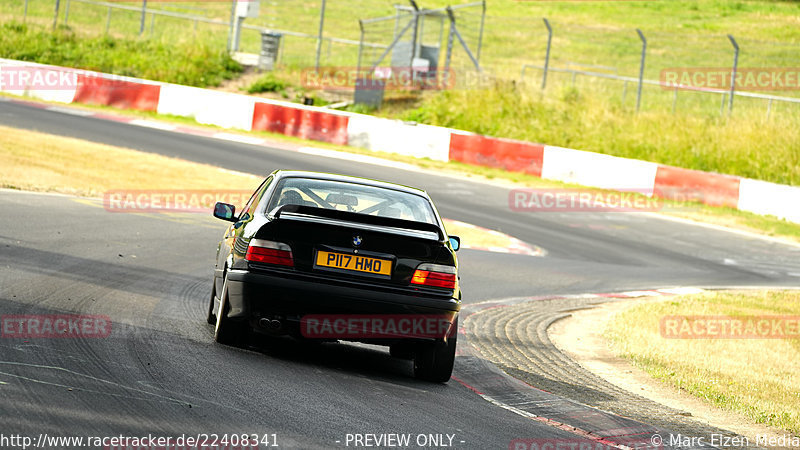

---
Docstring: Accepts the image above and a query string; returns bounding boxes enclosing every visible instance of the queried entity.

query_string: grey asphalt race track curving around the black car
[0,101,800,449]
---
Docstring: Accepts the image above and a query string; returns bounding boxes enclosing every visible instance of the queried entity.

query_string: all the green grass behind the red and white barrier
[0,0,800,185]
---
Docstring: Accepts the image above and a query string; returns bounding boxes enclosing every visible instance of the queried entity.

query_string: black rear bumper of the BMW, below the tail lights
[228,270,461,344]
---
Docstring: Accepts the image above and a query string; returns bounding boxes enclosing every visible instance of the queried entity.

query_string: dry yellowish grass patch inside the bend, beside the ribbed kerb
[605,291,800,433]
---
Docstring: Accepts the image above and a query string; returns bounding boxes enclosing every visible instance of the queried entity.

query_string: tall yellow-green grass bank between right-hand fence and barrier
[400,83,800,185]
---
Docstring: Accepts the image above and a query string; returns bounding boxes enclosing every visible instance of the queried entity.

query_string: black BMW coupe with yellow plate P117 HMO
[208,170,461,382]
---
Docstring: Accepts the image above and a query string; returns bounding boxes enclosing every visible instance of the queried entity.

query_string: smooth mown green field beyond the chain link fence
[7,0,800,79]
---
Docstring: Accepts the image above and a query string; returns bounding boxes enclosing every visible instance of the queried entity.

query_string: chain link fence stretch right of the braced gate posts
[483,16,800,117]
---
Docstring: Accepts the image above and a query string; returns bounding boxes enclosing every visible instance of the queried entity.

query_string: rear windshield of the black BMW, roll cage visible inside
[267,178,438,225]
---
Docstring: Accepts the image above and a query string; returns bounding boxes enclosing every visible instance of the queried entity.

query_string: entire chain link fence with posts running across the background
[0,0,800,117]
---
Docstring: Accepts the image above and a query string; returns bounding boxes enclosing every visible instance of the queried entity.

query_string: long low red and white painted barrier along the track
[0,59,800,223]
